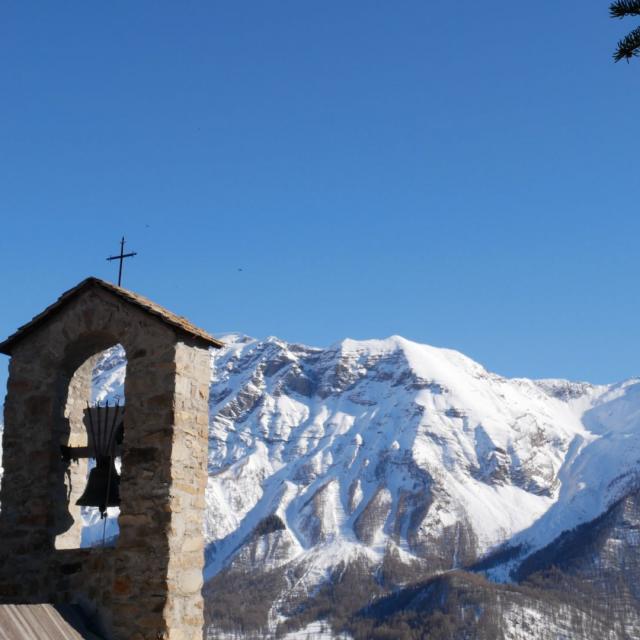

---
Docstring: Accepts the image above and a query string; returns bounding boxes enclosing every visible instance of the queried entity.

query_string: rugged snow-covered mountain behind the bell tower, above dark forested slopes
[5,335,640,638]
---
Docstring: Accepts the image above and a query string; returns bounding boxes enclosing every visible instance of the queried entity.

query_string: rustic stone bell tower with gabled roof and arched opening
[0,278,222,640]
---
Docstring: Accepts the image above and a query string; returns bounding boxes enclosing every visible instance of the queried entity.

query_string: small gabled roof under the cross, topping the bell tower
[0,277,224,356]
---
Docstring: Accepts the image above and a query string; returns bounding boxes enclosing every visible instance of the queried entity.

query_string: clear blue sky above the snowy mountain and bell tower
[0,0,640,387]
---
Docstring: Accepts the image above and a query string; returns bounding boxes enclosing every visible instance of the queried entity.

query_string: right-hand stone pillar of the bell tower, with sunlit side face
[107,341,210,640]
